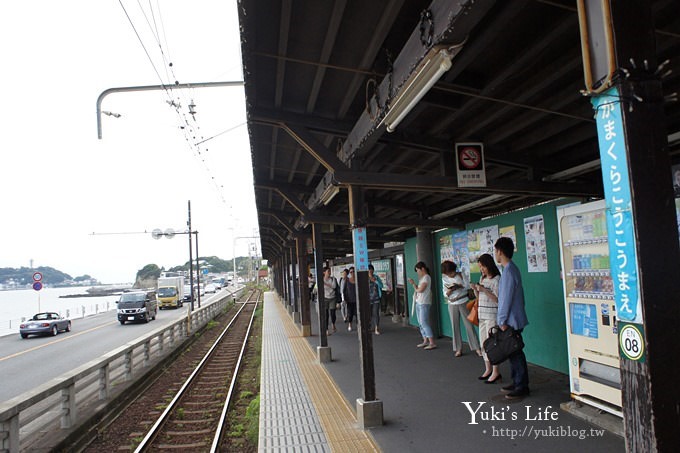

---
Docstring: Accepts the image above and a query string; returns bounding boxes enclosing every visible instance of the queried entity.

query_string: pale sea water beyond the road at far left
[0,287,119,336]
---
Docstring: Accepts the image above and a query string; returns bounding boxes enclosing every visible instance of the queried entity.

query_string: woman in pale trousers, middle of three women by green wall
[442,260,482,357]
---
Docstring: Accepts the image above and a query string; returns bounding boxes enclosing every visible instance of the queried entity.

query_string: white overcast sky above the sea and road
[0,0,259,283]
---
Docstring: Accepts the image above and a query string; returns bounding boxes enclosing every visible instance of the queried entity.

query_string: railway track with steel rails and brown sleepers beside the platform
[135,290,262,453]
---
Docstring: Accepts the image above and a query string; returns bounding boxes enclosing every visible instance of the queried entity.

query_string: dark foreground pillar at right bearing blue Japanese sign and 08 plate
[577,0,680,451]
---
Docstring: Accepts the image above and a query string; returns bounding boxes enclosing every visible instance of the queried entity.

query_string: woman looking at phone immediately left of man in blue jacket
[471,253,501,384]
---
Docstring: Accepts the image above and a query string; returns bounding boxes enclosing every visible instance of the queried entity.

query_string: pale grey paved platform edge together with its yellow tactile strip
[259,292,380,452]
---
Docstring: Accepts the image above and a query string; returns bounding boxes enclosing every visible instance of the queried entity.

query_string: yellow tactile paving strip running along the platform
[265,298,381,452]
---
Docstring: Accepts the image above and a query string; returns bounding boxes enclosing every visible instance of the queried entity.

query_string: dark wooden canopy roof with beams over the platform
[239,0,680,258]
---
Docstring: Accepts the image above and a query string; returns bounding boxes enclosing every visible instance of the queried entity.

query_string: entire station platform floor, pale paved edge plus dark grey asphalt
[259,292,625,453]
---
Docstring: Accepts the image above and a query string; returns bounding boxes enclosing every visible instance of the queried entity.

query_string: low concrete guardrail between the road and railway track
[0,288,245,453]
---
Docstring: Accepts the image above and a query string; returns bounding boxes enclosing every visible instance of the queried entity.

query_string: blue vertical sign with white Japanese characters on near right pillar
[592,87,642,324]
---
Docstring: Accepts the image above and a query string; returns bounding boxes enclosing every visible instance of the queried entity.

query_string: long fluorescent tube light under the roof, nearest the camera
[383,47,454,132]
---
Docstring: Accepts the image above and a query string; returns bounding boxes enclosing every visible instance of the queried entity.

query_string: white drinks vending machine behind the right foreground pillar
[557,201,622,416]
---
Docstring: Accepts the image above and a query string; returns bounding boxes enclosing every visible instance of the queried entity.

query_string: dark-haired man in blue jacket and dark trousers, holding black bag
[494,237,529,400]
